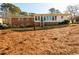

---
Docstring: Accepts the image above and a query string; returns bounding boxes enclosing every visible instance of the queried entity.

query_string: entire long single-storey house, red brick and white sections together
[2,14,70,27]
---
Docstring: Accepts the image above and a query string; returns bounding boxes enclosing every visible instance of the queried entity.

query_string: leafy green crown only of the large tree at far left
[1,3,21,15]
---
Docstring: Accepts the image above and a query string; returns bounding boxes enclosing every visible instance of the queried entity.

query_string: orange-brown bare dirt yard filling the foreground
[0,25,79,55]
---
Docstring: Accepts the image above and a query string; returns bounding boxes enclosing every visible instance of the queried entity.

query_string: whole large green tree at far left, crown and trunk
[1,3,21,23]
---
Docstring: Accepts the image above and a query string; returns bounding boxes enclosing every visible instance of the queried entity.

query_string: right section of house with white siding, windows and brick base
[34,14,70,26]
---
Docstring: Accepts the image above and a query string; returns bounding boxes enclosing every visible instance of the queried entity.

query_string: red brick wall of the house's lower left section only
[11,18,34,27]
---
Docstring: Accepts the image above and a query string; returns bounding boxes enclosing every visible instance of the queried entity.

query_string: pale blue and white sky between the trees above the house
[15,3,66,13]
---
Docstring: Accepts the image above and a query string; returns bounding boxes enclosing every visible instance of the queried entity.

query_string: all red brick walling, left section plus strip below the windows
[11,18,57,27]
